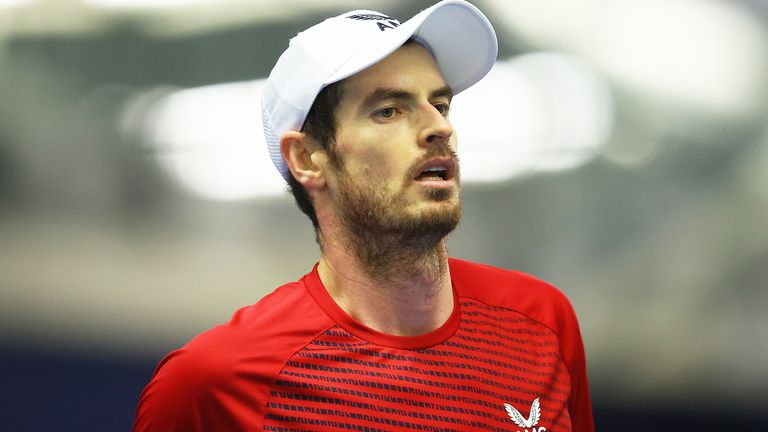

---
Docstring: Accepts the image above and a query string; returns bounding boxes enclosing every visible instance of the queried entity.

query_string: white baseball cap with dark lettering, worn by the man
[261,0,498,180]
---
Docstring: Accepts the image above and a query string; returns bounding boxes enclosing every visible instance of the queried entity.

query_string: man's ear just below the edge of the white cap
[280,131,325,189]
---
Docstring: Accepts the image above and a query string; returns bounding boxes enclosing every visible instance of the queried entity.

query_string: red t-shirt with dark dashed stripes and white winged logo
[133,259,594,432]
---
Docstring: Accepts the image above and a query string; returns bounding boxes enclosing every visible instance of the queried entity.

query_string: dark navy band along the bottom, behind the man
[0,349,768,432]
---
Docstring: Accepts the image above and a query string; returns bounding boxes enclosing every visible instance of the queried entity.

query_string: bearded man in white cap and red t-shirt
[134,0,594,432]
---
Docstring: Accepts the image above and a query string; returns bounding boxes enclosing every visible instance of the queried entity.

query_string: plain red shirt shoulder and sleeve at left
[137,281,332,430]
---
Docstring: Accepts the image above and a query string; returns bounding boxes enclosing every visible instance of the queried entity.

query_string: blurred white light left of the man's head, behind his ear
[126,80,285,201]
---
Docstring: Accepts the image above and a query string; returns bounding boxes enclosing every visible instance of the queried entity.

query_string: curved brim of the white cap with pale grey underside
[325,0,498,93]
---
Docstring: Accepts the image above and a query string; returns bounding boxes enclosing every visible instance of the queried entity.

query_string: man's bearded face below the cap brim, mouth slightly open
[328,43,461,238]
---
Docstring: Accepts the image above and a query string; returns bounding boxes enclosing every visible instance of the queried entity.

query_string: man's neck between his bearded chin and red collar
[318,233,453,336]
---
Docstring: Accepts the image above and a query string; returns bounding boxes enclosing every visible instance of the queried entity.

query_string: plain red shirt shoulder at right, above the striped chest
[449,258,576,334]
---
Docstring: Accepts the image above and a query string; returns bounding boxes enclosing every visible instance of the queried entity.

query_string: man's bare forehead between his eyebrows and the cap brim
[342,42,446,101]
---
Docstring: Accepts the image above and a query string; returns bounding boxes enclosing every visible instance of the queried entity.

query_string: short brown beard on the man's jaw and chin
[332,149,462,280]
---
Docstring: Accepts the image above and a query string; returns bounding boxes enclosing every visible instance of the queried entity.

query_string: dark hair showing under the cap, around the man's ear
[288,81,342,231]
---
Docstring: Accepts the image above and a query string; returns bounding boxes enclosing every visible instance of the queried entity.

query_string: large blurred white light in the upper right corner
[593,0,768,118]
